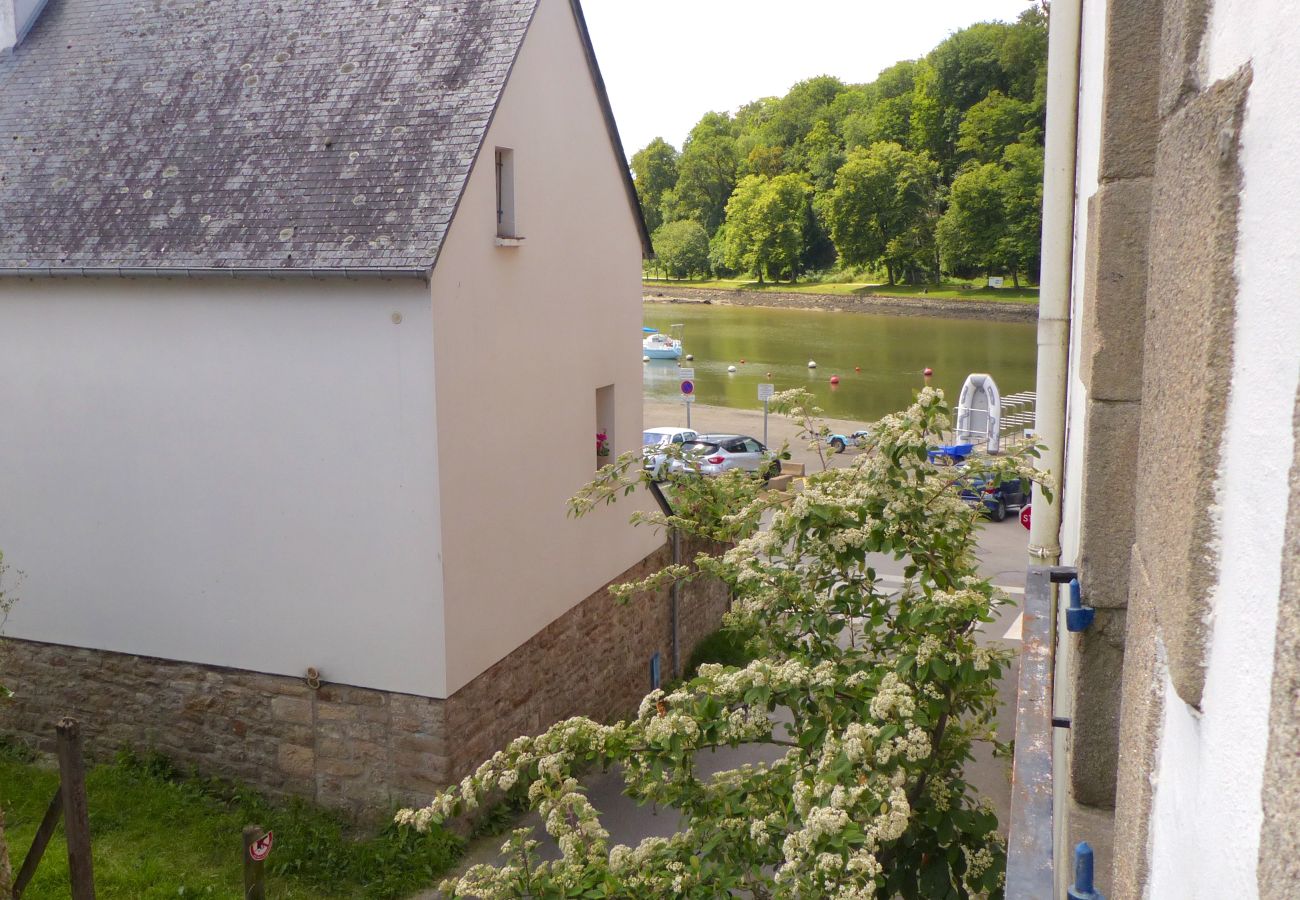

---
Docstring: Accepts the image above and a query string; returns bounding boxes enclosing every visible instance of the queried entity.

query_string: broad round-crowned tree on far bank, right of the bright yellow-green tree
[822,142,939,285]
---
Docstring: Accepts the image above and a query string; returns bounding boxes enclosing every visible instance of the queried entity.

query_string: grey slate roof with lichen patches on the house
[0,0,644,271]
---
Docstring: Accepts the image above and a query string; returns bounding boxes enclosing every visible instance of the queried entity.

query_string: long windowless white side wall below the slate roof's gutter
[0,278,445,696]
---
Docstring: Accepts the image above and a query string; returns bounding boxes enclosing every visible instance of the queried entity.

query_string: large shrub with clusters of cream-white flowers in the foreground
[398,388,1036,900]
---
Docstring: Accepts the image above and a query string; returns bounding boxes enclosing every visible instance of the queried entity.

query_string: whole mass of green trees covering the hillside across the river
[632,7,1047,285]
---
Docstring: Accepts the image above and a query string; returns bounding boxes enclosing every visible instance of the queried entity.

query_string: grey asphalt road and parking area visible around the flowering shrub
[423,401,1028,899]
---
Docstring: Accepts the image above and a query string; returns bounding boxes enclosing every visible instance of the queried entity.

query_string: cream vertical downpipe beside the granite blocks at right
[1030,0,1083,896]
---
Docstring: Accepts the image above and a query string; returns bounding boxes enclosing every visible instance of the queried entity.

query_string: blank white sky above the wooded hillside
[582,0,1031,157]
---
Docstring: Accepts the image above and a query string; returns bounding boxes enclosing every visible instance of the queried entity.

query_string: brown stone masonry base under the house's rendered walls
[0,545,728,815]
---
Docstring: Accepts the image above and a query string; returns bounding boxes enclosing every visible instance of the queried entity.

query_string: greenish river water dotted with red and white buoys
[642,303,1036,423]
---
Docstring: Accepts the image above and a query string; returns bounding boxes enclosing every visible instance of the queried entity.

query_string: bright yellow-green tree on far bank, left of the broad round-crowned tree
[727,174,809,284]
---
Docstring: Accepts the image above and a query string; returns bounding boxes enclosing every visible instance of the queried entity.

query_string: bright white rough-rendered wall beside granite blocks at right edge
[1151,0,1300,900]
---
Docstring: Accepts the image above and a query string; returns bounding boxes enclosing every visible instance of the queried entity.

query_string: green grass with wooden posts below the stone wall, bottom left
[0,750,460,900]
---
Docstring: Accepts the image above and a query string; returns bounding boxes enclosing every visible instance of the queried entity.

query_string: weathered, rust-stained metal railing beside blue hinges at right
[1006,566,1076,900]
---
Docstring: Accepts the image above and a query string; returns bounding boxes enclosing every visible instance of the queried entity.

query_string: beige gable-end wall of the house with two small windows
[433,0,663,692]
